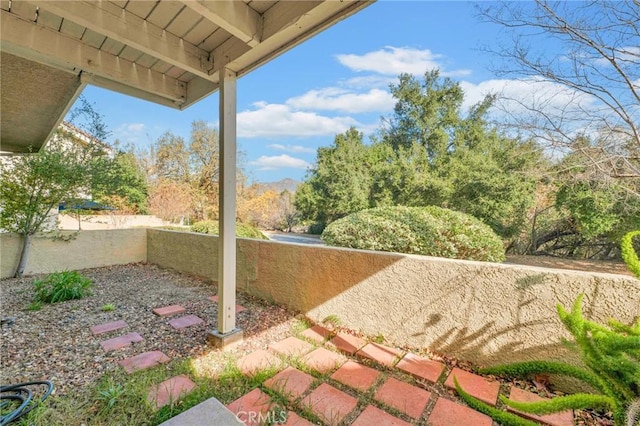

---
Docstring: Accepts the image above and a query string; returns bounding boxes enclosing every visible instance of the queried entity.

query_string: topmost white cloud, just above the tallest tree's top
[337,46,471,77]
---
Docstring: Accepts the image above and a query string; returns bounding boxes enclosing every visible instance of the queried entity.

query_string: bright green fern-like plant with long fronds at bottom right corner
[456,294,640,426]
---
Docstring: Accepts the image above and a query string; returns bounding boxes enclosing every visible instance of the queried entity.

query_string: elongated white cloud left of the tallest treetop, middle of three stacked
[287,87,395,114]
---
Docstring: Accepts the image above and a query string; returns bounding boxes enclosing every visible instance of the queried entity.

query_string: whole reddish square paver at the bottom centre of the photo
[300,383,358,425]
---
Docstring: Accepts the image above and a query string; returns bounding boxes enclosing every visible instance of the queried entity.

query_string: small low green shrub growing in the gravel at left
[33,271,93,303]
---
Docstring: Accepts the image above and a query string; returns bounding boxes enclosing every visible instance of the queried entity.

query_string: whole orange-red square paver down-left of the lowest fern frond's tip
[374,377,431,419]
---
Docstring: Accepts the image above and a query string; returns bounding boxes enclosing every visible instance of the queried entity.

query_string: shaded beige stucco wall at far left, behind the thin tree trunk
[0,229,147,278]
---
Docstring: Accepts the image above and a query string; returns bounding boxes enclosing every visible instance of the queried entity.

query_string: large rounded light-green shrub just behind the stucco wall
[322,206,505,262]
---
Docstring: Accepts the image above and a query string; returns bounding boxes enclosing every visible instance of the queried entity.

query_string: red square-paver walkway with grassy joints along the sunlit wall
[227,325,573,426]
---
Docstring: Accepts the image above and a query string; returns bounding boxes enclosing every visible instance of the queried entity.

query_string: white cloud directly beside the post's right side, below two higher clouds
[238,102,363,138]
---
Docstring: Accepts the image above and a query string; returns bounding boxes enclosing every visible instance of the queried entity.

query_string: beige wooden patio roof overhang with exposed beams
[0,0,371,152]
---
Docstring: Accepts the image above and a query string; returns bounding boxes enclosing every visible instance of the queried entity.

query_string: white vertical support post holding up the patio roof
[211,68,242,346]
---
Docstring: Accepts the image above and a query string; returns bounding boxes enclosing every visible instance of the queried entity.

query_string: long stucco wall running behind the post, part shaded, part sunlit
[147,229,640,365]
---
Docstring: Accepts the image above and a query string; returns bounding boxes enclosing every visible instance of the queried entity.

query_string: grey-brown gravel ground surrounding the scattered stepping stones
[0,264,296,395]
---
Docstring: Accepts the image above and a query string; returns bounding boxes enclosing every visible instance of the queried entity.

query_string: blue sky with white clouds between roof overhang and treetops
[69,1,560,182]
